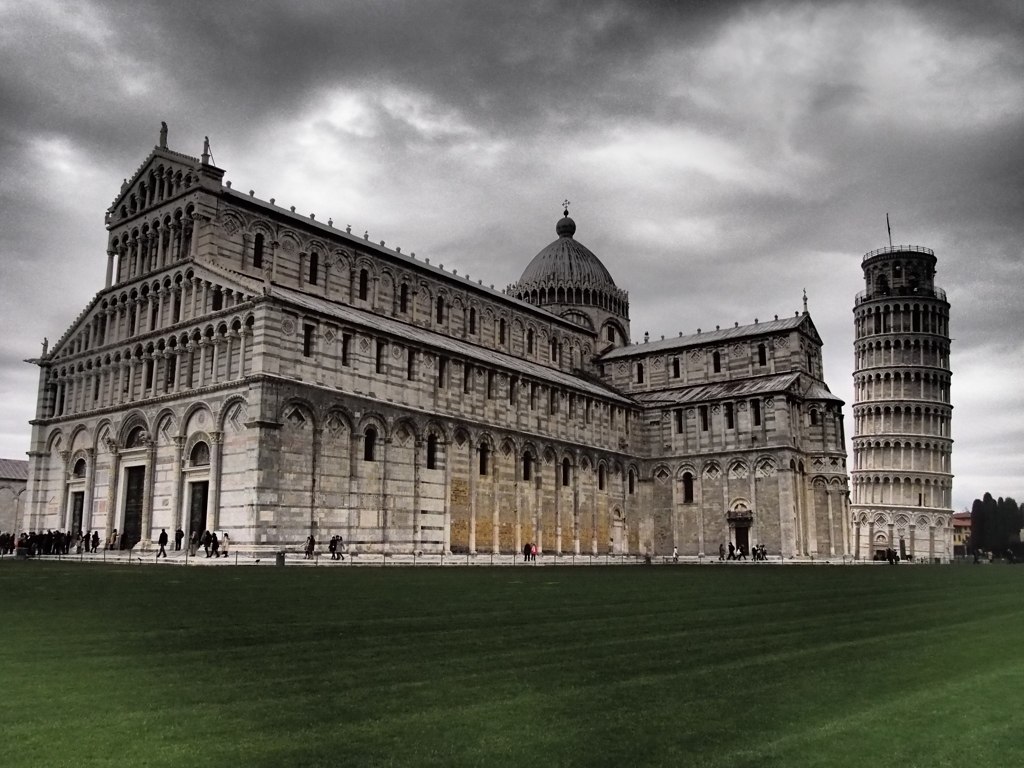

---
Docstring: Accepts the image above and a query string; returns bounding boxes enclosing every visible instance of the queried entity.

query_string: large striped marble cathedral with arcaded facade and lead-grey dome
[19,126,856,560]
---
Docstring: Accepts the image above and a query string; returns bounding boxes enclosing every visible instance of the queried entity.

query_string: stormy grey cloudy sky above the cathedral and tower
[0,0,1024,509]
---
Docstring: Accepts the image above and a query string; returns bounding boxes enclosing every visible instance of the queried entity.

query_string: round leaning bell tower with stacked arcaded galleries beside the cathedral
[850,246,953,562]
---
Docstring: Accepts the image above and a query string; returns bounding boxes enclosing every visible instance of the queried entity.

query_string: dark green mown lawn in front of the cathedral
[0,560,1024,767]
